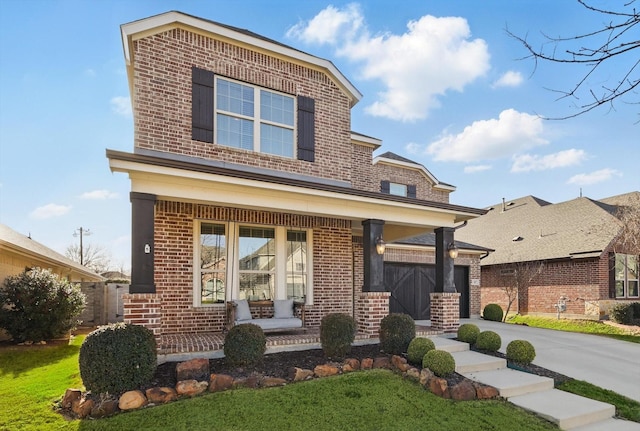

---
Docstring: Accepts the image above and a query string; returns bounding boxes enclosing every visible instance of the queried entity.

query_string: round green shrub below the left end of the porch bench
[224,323,267,366]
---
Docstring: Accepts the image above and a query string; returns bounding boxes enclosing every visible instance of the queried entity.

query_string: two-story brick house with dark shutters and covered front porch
[107,12,484,335]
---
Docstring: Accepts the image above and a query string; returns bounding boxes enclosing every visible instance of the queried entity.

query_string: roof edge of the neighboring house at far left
[0,223,103,280]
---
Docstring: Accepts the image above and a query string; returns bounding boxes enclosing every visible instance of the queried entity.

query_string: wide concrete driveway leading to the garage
[460,319,640,401]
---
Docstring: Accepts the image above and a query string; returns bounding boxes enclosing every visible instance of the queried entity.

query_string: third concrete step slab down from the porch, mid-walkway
[464,368,553,398]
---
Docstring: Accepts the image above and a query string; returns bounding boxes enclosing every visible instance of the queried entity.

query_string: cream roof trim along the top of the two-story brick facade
[120,11,362,106]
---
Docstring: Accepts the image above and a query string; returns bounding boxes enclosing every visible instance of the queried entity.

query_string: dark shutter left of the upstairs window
[191,66,214,143]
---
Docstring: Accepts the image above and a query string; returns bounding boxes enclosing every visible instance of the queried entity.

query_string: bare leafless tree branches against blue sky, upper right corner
[507,0,640,120]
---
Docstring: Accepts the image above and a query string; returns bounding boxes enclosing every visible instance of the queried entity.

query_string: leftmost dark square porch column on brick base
[129,192,156,293]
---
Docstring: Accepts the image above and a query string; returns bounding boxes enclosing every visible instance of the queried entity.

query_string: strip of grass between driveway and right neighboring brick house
[507,315,640,343]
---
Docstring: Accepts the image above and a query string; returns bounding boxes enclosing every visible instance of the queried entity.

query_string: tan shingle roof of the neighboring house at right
[456,196,636,265]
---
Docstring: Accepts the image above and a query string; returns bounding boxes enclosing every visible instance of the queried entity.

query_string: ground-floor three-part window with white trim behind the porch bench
[194,221,313,306]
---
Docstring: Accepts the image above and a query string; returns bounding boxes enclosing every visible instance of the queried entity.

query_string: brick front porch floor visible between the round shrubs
[158,321,444,364]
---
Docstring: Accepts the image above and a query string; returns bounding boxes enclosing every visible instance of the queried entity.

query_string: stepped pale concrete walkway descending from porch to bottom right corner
[430,337,640,431]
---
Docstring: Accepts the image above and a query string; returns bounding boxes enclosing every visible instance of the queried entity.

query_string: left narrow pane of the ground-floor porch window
[199,223,227,304]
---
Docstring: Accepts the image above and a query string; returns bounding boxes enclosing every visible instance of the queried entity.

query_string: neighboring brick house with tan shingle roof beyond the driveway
[456,192,640,318]
